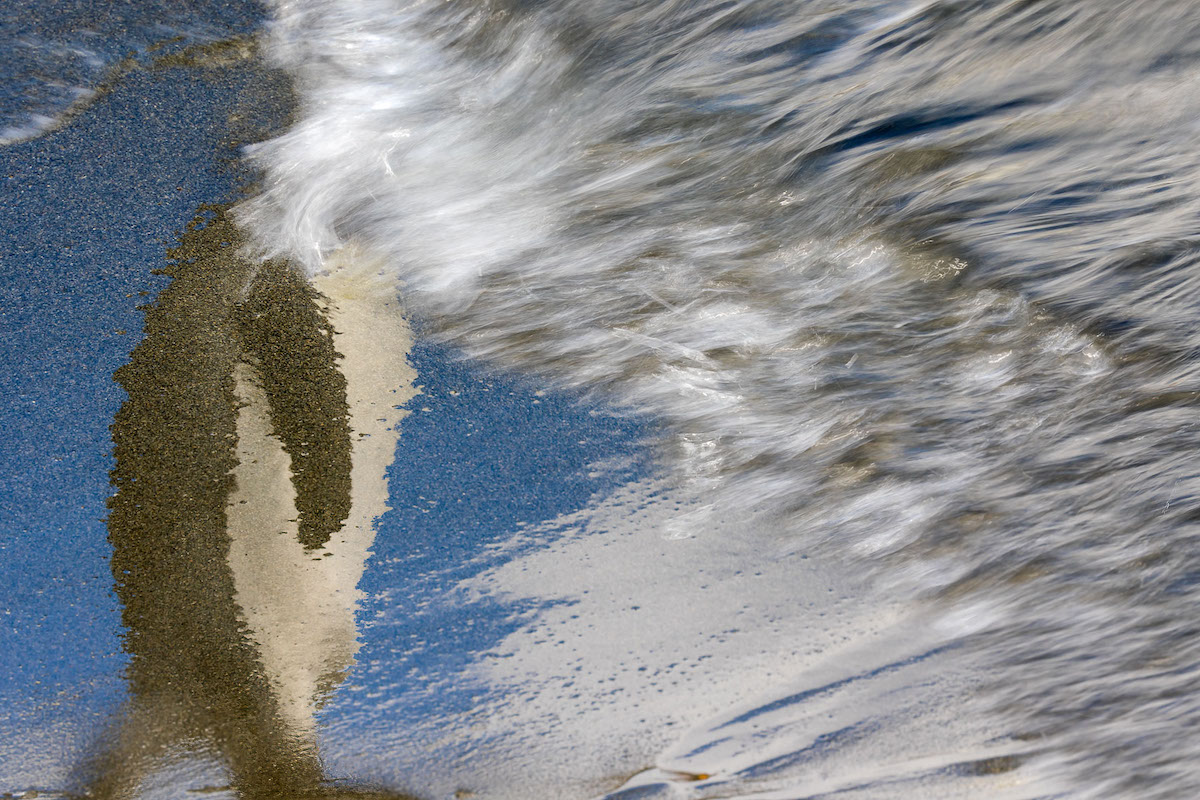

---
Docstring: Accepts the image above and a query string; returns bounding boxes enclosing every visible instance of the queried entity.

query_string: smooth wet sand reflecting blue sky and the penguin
[0,15,1041,800]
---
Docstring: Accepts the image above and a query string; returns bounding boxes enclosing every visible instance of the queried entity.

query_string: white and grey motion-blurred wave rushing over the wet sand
[240,0,1200,798]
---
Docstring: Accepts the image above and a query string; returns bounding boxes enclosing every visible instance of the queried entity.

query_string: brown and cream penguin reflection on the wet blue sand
[80,209,413,800]
